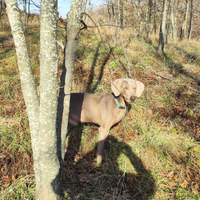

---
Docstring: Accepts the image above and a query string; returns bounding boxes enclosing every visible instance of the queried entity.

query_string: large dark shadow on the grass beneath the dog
[61,125,155,200]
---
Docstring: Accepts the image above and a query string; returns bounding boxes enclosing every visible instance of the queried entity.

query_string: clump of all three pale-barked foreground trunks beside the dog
[6,0,82,199]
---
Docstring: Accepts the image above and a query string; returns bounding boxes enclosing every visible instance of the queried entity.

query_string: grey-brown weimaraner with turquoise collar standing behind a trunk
[68,78,144,164]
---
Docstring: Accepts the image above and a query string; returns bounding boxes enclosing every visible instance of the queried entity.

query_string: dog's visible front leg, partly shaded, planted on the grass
[97,126,110,165]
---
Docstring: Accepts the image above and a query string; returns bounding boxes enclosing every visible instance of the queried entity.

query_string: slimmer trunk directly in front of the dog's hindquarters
[58,0,82,160]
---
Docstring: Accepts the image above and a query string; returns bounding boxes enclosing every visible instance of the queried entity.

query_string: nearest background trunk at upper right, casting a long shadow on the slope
[158,0,168,53]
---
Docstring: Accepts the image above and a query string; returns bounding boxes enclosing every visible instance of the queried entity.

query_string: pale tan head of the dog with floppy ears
[111,78,144,103]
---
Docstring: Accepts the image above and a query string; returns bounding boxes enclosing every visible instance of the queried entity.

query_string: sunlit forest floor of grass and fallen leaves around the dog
[0,13,200,200]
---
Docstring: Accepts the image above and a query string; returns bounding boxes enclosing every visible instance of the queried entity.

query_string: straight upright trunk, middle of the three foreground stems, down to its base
[37,0,60,199]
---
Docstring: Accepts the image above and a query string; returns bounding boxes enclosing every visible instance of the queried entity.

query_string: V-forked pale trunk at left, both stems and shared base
[6,0,60,199]
